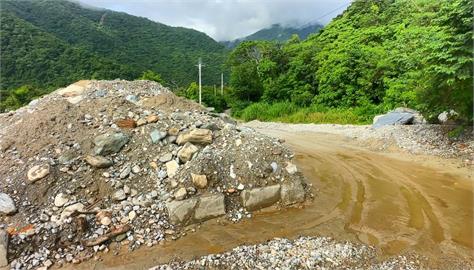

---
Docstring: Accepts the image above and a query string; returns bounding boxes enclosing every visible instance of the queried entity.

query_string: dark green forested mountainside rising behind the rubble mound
[0,0,225,89]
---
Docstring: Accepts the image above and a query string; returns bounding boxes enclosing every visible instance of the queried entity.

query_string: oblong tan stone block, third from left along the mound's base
[240,184,280,210]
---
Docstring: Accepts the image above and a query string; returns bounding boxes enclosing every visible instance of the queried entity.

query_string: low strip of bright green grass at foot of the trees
[240,102,382,125]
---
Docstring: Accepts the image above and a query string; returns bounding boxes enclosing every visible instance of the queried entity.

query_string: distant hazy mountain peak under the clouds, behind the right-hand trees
[222,23,323,48]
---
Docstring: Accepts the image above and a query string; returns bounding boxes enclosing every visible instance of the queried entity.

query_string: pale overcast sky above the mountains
[79,0,351,41]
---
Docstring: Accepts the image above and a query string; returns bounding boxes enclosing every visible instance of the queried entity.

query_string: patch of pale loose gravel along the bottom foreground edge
[151,237,425,270]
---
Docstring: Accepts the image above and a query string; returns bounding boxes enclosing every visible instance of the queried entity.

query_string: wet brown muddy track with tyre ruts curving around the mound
[74,130,474,269]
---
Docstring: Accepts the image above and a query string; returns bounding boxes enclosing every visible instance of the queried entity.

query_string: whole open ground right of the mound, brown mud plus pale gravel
[76,122,474,269]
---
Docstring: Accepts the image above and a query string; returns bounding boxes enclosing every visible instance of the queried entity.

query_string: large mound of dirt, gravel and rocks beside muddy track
[0,80,309,269]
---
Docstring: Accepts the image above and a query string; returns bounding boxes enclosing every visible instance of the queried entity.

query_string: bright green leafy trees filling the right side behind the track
[228,0,473,122]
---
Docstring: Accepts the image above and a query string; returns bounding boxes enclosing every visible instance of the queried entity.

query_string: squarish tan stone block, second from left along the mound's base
[194,194,225,221]
